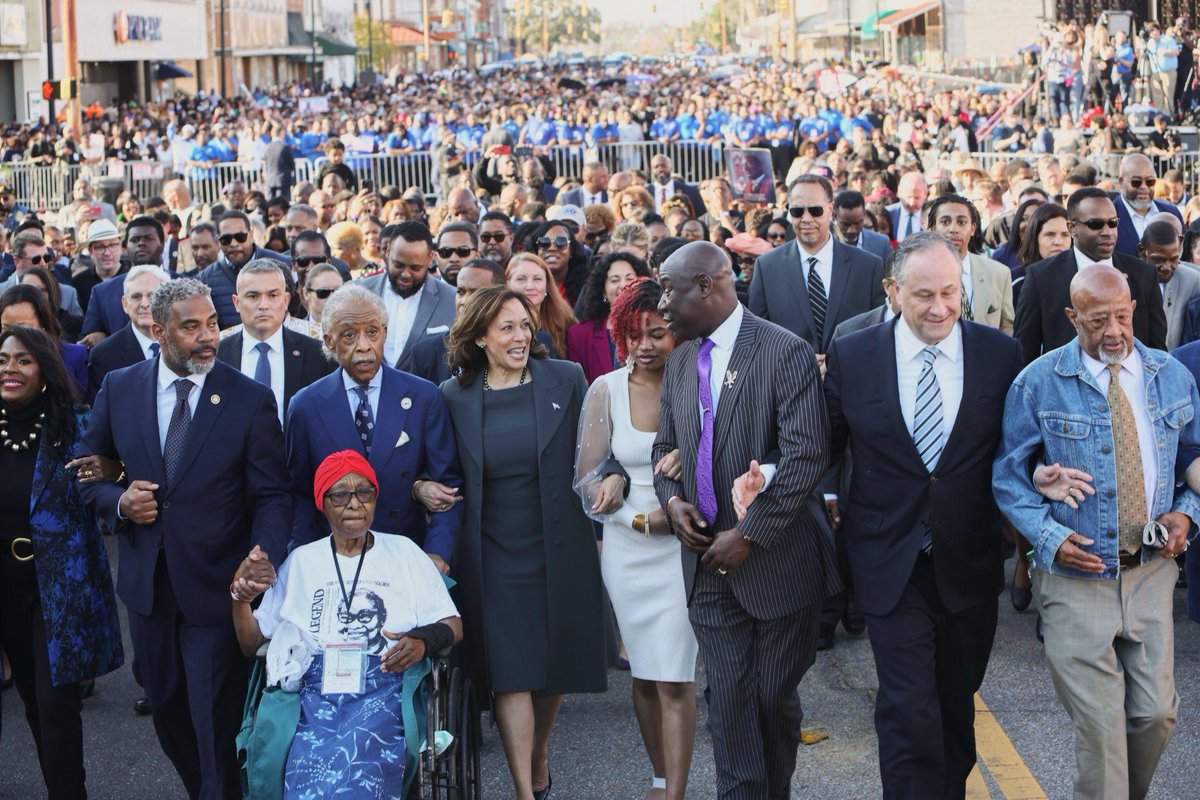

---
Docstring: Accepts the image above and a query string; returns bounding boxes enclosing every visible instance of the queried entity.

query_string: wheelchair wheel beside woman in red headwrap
[407,650,482,800]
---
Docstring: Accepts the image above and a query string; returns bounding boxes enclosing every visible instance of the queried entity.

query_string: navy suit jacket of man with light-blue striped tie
[825,320,1021,615]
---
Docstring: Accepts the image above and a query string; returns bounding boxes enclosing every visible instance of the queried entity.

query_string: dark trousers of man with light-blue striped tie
[866,555,998,800]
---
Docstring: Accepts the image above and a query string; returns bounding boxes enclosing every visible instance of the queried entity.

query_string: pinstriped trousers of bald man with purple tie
[689,567,820,800]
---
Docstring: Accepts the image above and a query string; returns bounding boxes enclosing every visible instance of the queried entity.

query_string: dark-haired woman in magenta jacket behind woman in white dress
[566,253,650,385]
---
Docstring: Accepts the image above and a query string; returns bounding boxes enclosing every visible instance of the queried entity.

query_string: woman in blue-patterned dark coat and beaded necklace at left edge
[0,323,124,800]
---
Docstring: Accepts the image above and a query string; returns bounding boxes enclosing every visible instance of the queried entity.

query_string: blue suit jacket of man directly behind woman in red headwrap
[287,366,462,563]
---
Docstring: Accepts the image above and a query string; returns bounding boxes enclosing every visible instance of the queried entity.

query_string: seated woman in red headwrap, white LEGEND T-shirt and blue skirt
[229,450,462,799]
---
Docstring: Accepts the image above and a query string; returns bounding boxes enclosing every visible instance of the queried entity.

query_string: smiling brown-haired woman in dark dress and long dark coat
[442,287,606,800]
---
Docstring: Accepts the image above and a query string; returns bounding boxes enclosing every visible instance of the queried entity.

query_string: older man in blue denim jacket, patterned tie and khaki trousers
[994,265,1200,800]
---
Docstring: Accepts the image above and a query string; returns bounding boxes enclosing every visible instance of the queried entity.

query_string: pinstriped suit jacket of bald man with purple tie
[652,312,840,620]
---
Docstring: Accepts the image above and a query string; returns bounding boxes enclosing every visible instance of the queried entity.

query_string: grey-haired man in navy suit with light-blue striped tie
[823,233,1022,799]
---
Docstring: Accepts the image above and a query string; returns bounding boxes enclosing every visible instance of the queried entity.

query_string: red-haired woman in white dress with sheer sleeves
[575,278,697,800]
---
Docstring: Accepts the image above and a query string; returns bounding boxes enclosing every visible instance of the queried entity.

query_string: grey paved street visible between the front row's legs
[0,551,1200,800]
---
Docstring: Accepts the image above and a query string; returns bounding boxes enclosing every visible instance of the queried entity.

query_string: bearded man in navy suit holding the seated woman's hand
[79,279,292,800]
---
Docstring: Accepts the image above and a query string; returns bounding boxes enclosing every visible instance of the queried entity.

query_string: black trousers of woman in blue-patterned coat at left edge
[0,556,88,800]
